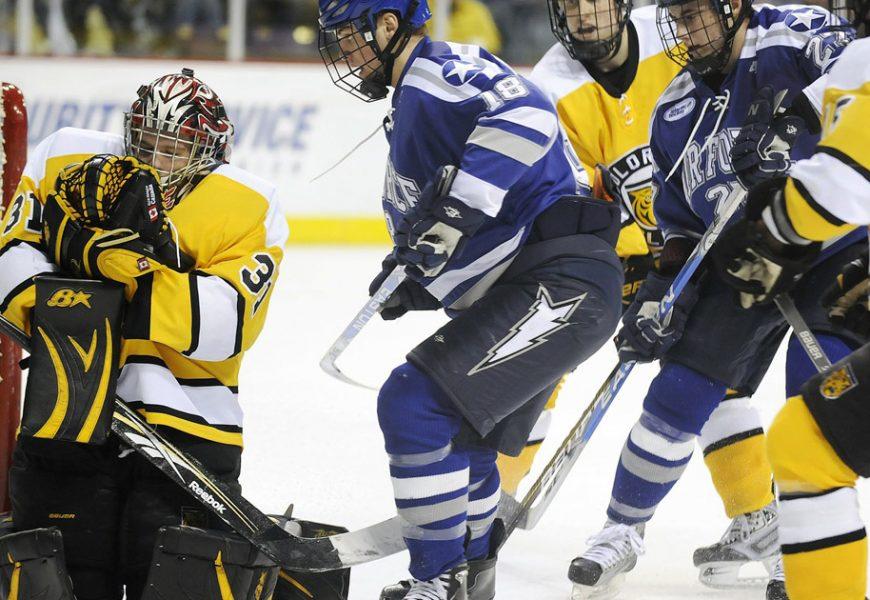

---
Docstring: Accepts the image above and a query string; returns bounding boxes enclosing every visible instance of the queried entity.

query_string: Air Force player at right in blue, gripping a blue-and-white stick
[572,0,859,598]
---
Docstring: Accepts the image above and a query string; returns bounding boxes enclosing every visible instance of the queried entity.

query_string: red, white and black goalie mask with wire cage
[124,69,233,208]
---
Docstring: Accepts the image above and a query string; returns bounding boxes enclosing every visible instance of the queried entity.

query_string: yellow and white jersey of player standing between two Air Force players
[530,6,679,257]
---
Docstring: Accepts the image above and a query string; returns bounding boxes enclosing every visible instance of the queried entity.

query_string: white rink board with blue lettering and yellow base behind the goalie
[0,58,390,242]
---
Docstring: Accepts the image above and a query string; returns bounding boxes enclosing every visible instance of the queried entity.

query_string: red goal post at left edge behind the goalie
[0,83,27,511]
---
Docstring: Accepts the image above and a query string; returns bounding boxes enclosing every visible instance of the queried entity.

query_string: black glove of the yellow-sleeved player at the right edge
[712,178,821,308]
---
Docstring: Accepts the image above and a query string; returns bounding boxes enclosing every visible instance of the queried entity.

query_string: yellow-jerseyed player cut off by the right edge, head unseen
[716,1,870,600]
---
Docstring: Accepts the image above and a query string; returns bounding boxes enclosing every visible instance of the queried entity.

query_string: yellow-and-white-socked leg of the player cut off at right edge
[768,346,870,600]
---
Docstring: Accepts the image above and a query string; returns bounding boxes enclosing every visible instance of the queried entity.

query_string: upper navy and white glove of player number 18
[393,165,486,280]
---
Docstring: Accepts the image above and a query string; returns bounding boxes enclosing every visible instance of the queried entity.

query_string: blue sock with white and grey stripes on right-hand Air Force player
[607,363,725,525]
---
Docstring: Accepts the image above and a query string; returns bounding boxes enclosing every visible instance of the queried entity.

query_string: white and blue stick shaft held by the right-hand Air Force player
[499,190,746,537]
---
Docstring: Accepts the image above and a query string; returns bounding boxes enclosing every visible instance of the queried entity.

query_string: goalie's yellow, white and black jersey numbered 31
[0,128,287,446]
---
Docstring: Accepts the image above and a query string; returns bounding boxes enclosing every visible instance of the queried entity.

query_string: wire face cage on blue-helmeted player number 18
[319,15,387,102]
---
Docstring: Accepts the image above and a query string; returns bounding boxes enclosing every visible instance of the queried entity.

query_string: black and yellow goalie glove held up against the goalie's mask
[42,154,193,293]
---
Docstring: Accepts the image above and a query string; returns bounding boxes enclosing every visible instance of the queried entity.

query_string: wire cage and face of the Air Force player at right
[656,0,752,75]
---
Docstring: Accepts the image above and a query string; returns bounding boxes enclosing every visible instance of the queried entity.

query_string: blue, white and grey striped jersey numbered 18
[383,38,589,309]
